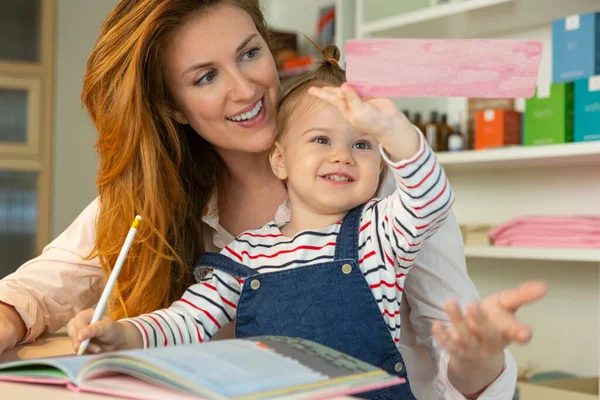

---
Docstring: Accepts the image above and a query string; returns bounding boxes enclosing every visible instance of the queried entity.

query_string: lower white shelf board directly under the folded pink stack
[465,246,600,263]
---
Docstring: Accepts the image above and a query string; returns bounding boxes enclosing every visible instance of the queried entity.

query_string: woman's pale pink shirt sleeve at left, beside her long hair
[0,199,104,343]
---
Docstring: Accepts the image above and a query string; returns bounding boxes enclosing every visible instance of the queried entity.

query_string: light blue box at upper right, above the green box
[552,13,600,82]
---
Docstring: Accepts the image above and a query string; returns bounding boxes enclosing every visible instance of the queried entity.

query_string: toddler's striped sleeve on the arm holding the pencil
[122,270,243,348]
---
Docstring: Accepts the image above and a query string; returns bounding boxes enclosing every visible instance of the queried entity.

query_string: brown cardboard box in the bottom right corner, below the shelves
[515,377,598,400]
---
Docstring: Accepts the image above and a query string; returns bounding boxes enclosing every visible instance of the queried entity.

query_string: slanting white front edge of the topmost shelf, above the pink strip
[358,0,514,36]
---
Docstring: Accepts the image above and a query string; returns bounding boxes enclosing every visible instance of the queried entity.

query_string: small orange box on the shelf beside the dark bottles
[475,110,521,150]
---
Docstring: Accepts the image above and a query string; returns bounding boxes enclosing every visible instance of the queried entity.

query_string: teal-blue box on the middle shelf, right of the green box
[573,75,600,142]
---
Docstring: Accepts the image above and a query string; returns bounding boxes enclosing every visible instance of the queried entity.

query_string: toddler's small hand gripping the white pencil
[67,308,143,354]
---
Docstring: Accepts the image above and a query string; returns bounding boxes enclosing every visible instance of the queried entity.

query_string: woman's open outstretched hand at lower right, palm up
[432,281,548,393]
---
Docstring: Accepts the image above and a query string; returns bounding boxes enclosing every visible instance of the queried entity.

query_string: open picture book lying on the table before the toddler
[0,336,404,400]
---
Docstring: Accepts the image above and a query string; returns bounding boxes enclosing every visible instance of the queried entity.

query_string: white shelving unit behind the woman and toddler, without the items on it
[346,0,600,376]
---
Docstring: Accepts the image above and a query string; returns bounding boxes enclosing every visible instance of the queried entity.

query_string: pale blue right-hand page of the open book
[78,339,329,398]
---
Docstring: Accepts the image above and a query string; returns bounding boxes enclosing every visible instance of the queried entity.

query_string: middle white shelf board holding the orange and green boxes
[437,141,600,172]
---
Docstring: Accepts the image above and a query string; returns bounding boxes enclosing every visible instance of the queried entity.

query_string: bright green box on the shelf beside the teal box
[523,83,573,146]
